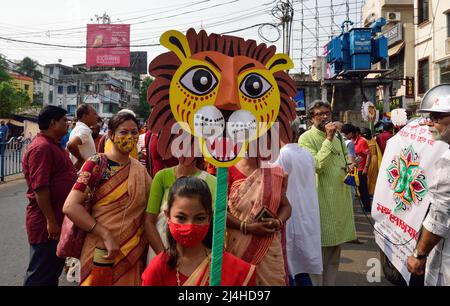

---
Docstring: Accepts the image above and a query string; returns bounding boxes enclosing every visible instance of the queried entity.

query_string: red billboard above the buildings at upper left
[86,24,130,68]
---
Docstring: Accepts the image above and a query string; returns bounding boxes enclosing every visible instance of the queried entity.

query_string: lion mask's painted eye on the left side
[180,67,217,96]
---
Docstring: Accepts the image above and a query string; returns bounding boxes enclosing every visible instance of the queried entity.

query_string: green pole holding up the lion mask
[209,168,228,286]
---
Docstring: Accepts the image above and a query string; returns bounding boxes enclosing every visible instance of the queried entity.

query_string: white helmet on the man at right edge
[418,84,450,113]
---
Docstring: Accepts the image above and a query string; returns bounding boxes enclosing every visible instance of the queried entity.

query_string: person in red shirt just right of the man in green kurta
[342,124,371,212]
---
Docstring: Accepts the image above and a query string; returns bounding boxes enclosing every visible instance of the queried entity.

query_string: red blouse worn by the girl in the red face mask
[142,252,256,286]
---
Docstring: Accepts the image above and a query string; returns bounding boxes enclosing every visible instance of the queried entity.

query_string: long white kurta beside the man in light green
[275,144,323,276]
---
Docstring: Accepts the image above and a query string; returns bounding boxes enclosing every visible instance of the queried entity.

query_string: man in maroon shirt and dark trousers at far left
[22,106,77,286]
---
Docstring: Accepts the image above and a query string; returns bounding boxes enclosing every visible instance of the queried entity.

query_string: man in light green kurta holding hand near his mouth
[299,100,356,286]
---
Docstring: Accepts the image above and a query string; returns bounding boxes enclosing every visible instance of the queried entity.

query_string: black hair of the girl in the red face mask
[166,176,213,270]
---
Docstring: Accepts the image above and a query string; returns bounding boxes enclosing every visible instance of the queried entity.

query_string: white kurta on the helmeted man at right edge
[423,150,450,286]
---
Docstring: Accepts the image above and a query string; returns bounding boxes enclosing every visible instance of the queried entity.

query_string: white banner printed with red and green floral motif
[372,120,448,283]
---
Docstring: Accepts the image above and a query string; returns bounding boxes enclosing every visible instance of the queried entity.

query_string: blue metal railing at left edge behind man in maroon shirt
[0,137,31,182]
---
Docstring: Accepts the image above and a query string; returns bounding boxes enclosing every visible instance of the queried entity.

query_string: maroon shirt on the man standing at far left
[22,134,77,244]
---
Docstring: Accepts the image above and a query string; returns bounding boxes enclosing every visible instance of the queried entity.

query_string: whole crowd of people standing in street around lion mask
[23,85,450,286]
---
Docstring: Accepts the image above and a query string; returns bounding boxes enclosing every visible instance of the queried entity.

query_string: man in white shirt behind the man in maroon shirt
[67,104,98,170]
